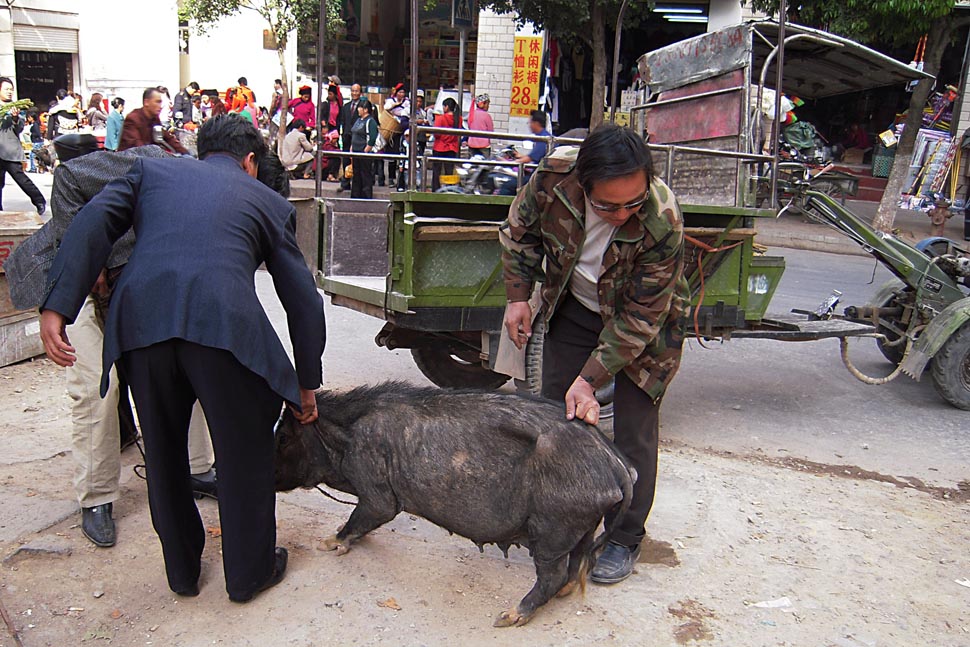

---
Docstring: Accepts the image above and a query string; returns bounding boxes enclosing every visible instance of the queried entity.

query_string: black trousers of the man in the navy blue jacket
[119,339,282,598]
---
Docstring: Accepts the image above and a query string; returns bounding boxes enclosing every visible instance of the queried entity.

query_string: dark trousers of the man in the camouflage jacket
[542,294,660,546]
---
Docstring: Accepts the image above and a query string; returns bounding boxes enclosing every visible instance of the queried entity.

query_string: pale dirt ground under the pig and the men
[0,360,970,647]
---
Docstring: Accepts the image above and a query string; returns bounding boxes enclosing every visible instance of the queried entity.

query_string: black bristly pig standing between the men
[276,382,636,627]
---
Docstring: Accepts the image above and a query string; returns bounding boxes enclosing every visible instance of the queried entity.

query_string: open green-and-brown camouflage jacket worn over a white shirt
[499,147,690,401]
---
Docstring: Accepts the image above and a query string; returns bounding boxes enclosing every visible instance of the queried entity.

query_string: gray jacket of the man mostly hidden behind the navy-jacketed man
[3,142,170,310]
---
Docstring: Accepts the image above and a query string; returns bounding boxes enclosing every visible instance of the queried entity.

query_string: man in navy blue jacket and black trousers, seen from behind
[41,115,326,602]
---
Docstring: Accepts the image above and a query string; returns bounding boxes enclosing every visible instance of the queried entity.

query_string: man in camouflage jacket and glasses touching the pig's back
[499,125,690,584]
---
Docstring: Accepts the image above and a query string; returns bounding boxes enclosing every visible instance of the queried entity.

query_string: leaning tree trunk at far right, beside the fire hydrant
[872,16,958,232]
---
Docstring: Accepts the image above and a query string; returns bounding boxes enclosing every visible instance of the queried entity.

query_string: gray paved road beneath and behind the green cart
[260,250,970,485]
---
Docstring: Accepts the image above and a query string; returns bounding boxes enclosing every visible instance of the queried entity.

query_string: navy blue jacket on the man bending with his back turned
[42,154,326,405]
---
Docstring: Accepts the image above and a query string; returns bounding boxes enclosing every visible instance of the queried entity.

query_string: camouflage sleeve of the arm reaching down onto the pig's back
[580,203,684,389]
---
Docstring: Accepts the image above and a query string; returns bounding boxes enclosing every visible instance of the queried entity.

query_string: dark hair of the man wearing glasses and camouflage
[576,123,653,193]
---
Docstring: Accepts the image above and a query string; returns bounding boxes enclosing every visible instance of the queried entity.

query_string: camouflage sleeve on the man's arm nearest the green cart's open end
[498,172,544,301]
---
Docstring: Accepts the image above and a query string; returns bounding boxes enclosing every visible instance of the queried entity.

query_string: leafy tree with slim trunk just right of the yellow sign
[479,0,654,128]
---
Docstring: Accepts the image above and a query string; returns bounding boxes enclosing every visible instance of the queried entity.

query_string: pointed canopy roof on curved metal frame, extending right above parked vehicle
[751,20,933,99]
